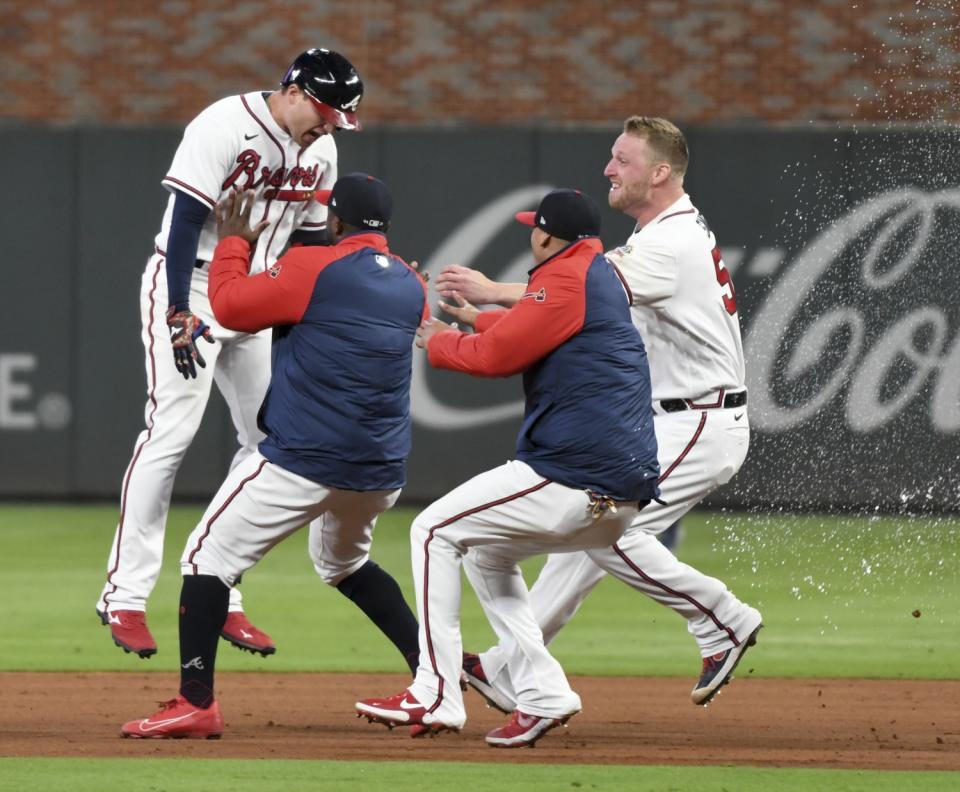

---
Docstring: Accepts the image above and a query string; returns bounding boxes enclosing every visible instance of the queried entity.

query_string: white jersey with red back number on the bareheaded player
[606,194,745,401]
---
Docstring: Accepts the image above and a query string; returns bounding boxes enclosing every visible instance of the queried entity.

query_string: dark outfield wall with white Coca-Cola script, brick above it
[0,0,960,511]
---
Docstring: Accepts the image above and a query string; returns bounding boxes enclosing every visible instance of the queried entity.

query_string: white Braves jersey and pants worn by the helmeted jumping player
[97,91,337,612]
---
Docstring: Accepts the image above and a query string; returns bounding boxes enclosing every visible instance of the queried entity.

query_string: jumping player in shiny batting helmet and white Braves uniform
[97,49,363,657]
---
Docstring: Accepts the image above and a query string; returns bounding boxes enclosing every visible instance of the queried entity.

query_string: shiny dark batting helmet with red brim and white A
[280,48,363,129]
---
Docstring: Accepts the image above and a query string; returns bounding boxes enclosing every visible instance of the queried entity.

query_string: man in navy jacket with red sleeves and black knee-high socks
[123,173,429,738]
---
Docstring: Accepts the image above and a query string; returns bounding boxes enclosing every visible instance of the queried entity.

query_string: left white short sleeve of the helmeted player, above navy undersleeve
[162,102,238,209]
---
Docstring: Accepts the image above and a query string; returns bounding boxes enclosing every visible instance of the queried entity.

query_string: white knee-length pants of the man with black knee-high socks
[180,451,400,586]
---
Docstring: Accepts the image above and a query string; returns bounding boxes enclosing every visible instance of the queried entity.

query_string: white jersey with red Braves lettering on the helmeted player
[156,91,337,273]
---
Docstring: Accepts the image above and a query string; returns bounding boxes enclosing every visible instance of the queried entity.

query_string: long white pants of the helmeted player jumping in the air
[97,254,271,612]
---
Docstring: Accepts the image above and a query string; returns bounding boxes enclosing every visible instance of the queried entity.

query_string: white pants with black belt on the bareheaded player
[464,408,761,700]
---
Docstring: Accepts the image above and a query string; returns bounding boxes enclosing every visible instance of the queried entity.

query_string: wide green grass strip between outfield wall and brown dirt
[0,505,960,679]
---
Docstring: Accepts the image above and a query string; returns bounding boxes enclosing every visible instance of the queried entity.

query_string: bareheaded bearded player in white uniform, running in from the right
[437,116,762,712]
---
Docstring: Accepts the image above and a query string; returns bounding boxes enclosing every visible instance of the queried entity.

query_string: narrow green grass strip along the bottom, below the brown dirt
[0,759,958,792]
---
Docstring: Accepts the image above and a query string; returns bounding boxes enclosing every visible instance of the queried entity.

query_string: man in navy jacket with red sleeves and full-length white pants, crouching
[357,190,660,747]
